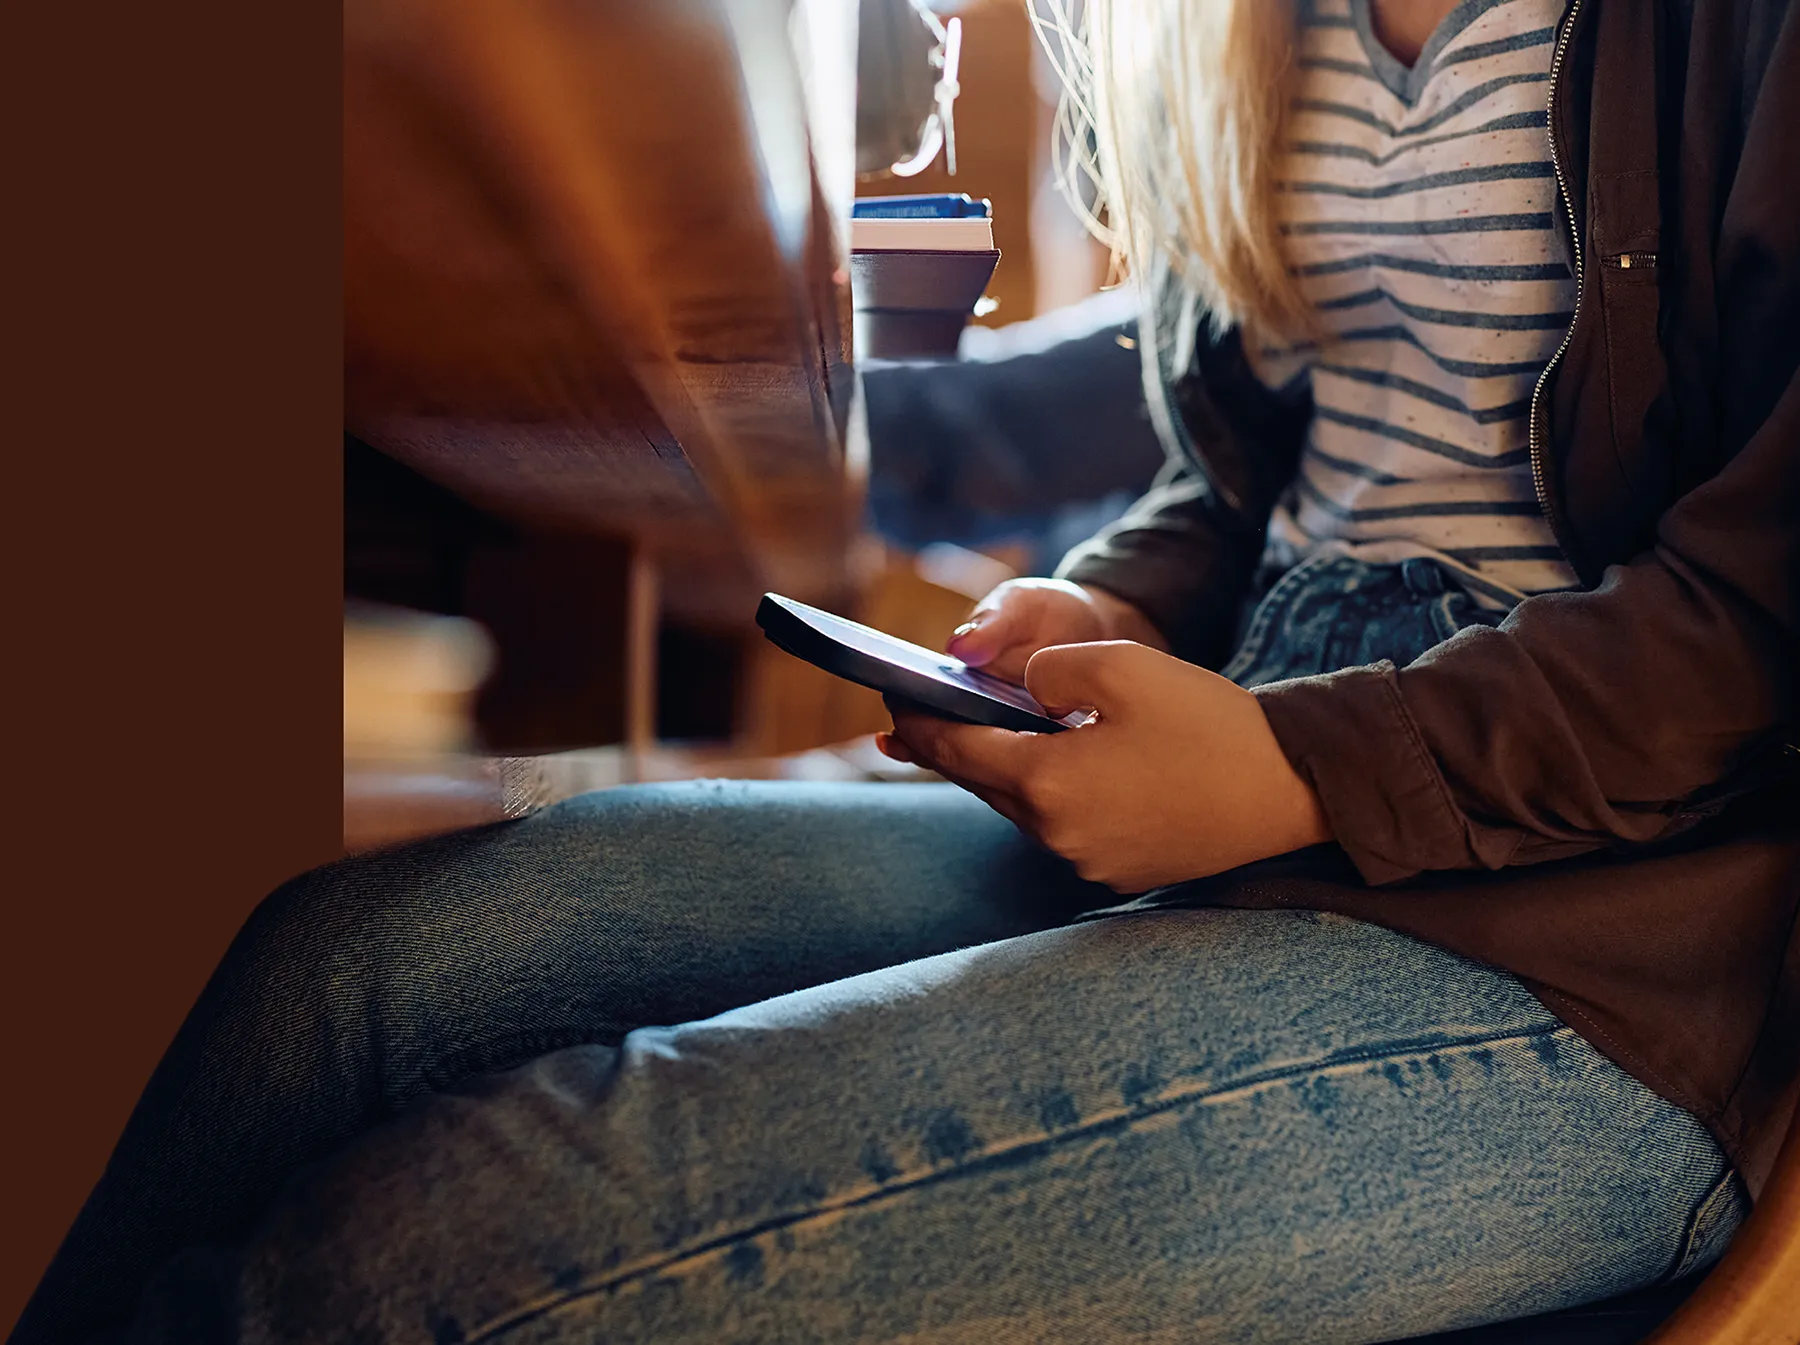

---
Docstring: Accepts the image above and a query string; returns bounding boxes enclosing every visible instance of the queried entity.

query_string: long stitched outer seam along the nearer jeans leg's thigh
[466,1021,1580,1345]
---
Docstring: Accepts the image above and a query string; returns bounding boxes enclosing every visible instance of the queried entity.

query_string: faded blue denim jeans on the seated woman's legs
[16,561,1744,1345]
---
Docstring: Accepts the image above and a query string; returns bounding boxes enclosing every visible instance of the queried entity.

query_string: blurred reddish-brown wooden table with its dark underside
[344,0,860,753]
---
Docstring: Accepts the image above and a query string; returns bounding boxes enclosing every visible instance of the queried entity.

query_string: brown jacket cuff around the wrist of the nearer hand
[1253,663,1478,884]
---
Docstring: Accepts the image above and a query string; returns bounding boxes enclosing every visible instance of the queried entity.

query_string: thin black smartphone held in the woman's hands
[756,592,1087,733]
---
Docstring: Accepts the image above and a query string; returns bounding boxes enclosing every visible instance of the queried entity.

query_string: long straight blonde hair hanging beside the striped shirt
[1031,0,1314,360]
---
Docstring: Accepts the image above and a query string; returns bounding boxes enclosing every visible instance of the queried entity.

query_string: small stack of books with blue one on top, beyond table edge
[850,194,1001,360]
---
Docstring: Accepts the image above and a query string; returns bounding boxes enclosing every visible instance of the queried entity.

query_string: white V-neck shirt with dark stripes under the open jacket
[1251,0,1577,607]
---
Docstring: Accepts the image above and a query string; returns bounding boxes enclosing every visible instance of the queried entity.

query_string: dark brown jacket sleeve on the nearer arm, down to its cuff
[1256,16,1800,882]
